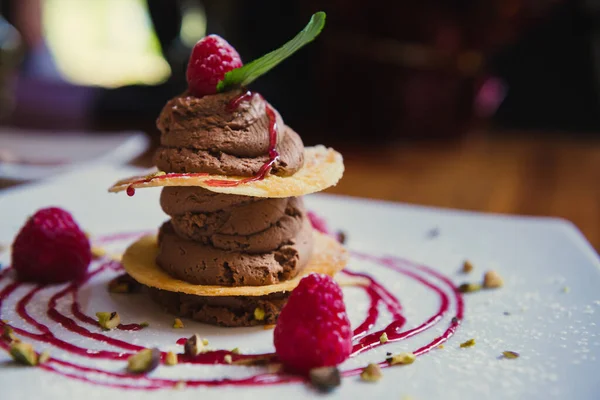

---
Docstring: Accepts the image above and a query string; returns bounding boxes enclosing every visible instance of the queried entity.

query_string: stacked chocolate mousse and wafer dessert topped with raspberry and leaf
[110,14,346,326]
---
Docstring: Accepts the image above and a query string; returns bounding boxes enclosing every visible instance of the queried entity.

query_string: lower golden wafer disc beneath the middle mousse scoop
[122,231,348,296]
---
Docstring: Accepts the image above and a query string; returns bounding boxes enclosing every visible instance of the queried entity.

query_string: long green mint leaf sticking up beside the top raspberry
[217,11,325,92]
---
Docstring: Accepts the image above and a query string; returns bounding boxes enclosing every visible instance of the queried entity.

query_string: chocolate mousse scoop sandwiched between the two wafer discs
[156,186,313,286]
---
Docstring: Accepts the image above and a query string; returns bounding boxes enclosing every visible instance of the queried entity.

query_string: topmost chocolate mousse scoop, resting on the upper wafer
[154,90,304,176]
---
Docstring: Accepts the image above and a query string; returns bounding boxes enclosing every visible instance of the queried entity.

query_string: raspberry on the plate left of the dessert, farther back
[12,207,92,283]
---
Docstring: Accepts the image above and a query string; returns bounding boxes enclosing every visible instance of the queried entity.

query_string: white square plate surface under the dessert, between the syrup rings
[0,166,600,400]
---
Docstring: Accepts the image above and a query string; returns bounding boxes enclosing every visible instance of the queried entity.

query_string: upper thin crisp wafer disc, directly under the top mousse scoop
[108,146,344,197]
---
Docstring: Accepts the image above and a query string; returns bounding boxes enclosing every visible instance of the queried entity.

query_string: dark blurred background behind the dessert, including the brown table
[0,0,600,250]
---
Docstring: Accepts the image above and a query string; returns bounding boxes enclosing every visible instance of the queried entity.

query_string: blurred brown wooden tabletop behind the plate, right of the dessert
[328,133,600,251]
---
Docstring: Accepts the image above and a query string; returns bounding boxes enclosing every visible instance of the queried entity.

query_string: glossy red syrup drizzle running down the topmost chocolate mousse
[205,91,279,187]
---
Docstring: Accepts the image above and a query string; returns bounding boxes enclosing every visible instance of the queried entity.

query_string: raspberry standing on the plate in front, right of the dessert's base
[274,274,352,373]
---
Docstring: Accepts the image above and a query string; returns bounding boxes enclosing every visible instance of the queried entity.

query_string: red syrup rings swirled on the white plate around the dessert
[0,233,464,390]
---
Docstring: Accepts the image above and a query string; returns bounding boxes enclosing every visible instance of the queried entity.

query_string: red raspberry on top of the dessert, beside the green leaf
[186,35,243,97]
